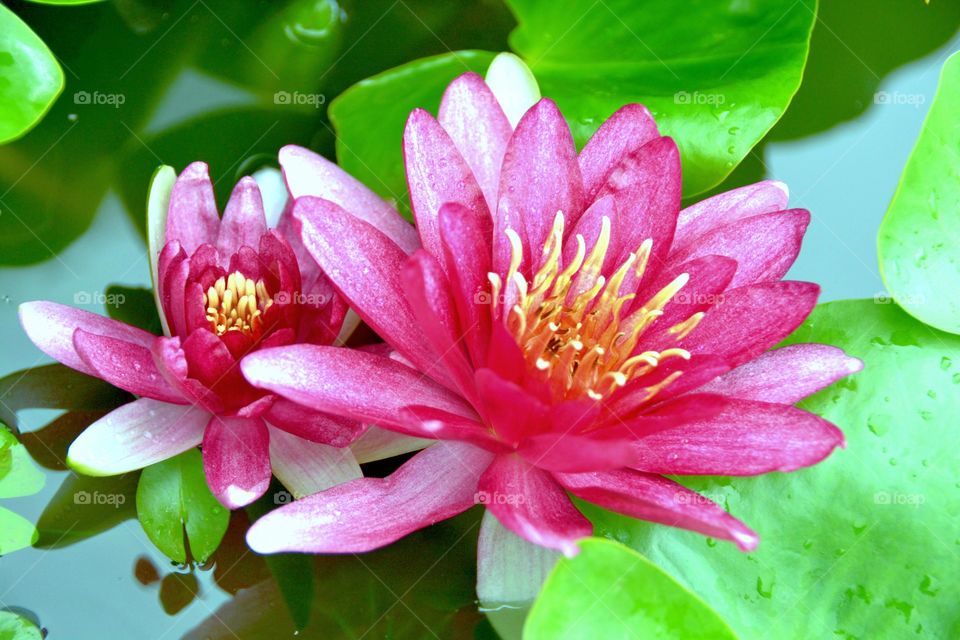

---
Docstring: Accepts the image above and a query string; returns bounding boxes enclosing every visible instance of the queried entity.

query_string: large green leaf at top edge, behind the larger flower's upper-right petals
[508,0,816,196]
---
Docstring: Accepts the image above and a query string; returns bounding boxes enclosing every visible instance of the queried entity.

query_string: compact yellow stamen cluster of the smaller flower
[203,271,273,338]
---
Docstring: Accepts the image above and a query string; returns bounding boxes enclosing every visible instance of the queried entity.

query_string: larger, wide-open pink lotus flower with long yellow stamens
[242,61,861,560]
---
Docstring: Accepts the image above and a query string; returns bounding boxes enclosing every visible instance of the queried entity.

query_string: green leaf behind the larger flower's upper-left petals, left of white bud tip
[330,51,494,215]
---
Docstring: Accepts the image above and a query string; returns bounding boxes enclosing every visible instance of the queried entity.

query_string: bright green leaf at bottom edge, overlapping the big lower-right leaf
[523,538,736,640]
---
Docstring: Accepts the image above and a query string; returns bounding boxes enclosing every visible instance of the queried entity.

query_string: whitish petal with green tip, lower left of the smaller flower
[67,398,210,476]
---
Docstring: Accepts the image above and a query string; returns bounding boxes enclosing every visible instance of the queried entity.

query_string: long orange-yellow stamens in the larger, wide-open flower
[488,212,703,400]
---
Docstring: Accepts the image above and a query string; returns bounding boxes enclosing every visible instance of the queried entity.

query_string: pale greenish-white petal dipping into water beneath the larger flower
[477,511,560,606]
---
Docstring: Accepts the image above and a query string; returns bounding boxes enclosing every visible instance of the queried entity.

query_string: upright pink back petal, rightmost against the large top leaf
[579,104,660,202]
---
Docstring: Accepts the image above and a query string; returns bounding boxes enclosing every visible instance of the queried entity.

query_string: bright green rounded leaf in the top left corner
[0,5,63,144]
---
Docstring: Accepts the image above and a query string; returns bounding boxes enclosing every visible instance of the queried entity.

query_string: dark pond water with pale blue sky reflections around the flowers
[0,0,960,640]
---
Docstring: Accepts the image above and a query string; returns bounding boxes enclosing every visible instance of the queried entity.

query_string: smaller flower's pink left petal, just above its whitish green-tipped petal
[73,329,187,404]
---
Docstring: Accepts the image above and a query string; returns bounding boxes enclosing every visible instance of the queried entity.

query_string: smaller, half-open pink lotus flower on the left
[20,159,424,508]
